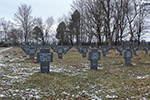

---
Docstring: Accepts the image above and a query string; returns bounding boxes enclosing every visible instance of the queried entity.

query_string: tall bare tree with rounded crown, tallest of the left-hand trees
[14,4,33,42]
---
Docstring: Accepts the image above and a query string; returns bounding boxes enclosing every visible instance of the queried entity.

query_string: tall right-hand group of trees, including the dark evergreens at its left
[56,0,150,46]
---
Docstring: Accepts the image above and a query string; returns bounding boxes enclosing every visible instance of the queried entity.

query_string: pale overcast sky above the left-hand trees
[0,0,73,22]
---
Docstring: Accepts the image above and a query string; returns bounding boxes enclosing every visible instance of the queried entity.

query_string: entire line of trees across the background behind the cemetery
[0,0,150,46]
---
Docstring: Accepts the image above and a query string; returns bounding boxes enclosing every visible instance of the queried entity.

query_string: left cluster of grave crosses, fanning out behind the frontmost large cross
[21,45,72,73]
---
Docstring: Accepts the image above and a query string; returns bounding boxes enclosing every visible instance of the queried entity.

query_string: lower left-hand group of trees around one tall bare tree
[0,4,55,44]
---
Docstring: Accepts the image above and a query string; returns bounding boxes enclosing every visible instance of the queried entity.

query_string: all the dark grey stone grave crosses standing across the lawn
[21,45,149,73]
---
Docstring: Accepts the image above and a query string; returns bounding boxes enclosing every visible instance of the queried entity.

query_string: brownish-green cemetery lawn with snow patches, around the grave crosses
[0,47,150,100]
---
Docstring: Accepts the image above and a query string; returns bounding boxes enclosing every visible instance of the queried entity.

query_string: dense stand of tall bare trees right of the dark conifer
[66,0,148,46]
